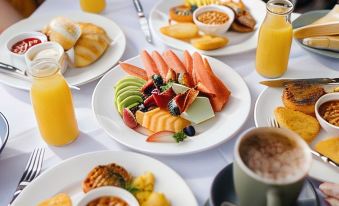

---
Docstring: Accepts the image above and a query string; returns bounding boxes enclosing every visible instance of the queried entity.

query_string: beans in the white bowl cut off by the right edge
[319,100,339,127]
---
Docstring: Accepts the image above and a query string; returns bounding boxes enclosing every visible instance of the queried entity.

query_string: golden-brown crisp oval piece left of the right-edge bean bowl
[274,107,320,143]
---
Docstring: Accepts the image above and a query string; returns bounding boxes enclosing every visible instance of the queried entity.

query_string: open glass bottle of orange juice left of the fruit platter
[28,58,79,146]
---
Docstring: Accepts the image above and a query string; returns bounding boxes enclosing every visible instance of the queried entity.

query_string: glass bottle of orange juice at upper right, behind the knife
[256,0,294,78]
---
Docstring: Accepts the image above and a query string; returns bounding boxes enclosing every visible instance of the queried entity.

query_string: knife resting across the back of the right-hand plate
[260,78,339,87]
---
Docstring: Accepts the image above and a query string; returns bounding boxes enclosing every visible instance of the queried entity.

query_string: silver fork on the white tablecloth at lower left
[9,148,45,206]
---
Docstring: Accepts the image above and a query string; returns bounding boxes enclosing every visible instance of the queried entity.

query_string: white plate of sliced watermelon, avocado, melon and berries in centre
[92,50,250,155]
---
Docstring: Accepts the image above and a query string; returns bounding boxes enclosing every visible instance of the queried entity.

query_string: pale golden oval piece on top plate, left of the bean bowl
[160,23,199,39]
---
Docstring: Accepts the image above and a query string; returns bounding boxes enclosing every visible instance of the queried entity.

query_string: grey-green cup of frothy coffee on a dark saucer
[233,127,312,206]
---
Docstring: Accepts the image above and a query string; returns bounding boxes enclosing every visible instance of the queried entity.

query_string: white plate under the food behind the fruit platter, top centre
[149,0,266,56]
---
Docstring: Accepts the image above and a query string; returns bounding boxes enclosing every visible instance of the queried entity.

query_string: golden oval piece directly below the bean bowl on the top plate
[191,35,229,50]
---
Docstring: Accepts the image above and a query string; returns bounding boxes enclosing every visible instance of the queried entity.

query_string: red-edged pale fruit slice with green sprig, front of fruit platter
[146,131,187,143]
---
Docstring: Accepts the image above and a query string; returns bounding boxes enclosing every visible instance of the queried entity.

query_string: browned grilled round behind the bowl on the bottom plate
[82,163,132,193]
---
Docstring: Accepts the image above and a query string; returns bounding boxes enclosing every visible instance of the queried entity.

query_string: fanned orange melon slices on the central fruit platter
[136,108,191,132]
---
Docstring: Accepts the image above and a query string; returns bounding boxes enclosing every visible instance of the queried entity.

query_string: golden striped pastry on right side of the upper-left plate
[74,23,111,67]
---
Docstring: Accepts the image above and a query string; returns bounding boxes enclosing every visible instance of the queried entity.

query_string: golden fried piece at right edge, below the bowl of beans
[315,137,339,164]
